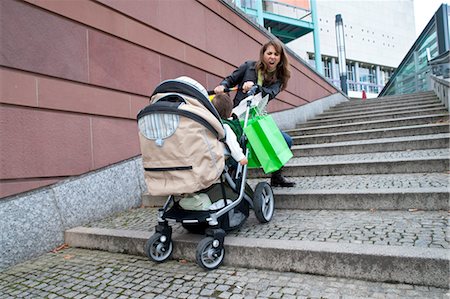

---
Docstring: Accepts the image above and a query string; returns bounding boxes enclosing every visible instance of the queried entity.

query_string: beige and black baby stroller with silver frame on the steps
[137,77,274,270]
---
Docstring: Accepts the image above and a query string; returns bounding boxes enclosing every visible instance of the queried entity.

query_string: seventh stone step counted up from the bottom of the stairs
[312,103,445,121]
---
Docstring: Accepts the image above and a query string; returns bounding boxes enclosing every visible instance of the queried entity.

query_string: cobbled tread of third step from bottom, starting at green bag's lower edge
[288,149,450,165]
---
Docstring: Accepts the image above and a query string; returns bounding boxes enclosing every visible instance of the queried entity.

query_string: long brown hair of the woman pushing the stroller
[256,40,291,90]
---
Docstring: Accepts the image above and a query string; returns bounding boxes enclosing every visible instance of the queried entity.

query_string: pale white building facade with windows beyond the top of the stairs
[287,0,416,98]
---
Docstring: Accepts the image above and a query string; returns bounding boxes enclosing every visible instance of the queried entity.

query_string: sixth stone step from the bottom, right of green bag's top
[285,113,449,136]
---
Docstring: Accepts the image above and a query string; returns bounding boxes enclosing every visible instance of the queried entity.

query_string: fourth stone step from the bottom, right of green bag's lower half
[291,134,450,157]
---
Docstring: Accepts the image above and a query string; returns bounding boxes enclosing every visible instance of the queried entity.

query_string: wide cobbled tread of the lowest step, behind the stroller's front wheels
[85,208,450,248]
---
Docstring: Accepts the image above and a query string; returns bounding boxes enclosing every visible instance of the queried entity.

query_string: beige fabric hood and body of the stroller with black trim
[137,78,225,195]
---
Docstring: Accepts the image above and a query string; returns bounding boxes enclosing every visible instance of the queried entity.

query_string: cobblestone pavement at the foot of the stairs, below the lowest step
[0,248,450,299]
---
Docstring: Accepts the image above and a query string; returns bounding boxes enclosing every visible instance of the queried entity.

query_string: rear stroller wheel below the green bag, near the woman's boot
[253,182,274,223]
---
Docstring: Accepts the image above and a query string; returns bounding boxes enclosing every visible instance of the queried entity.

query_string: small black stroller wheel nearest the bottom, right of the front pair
[195,237,225,270]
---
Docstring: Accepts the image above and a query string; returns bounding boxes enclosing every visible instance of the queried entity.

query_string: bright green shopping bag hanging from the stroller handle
[244,115,293,173]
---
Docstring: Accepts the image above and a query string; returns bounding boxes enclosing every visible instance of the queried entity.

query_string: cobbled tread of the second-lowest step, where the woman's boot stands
[249,173,450,193]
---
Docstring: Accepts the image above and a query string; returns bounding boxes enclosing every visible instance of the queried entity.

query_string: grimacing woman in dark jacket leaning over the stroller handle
[214,40,294,187]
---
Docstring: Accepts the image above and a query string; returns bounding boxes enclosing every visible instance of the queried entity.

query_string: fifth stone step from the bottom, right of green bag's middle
[292,124,450,145]
